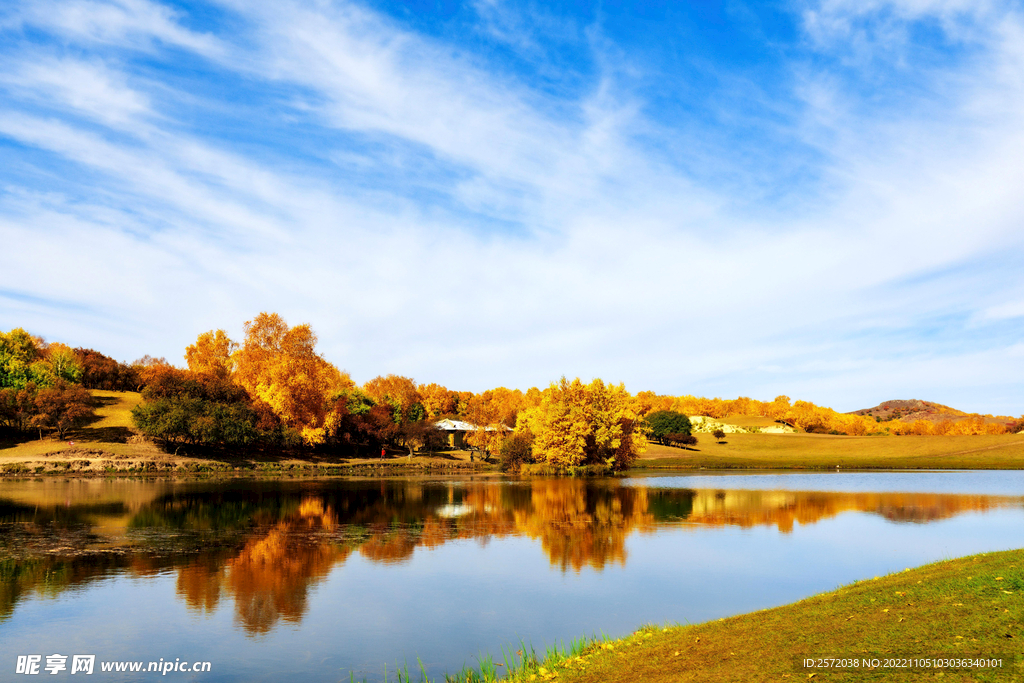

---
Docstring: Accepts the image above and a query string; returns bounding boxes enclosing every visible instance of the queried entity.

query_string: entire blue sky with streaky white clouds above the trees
[0,0,1024,415]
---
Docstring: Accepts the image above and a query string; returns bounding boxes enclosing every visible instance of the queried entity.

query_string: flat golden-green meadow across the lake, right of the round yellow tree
[635,434,1024,469]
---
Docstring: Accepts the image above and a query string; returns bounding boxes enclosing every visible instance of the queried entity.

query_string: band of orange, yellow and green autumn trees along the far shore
[0,312,1024,470]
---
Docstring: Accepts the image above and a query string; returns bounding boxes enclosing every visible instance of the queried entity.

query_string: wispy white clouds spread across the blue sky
[0,2,1024,412]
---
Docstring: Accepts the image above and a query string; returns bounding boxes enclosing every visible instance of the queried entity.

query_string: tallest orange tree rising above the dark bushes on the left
[232,312,353,444]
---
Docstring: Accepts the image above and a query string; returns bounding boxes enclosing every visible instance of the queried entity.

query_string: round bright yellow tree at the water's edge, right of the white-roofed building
[516,377,647,470]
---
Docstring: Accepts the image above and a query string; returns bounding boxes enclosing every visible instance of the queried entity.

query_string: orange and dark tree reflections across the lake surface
[0,479,1022,636]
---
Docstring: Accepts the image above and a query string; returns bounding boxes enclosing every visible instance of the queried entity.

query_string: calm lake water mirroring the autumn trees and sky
[0,472,1024,681]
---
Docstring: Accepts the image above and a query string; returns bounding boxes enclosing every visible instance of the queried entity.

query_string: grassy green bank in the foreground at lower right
[450,550,1024,683]
